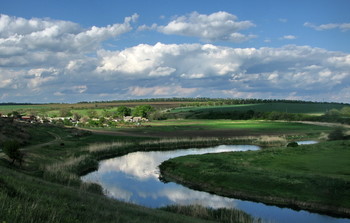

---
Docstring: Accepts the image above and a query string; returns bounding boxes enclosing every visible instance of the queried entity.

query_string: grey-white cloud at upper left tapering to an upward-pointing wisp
[0,14,138,62]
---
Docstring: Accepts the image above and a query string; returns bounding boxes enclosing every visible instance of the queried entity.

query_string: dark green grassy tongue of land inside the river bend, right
[161,141,350,217]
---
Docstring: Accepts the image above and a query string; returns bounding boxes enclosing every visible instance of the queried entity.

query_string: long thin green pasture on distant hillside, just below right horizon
[171,103,345,115]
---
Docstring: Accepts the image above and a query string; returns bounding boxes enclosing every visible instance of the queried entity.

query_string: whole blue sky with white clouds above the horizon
[0,0,350,103]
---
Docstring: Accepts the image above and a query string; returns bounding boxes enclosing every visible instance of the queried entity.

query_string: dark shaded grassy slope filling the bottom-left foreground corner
[0,166,215,223]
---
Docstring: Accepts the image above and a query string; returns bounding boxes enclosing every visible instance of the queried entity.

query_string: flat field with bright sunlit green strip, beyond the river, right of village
[105,120,331,137]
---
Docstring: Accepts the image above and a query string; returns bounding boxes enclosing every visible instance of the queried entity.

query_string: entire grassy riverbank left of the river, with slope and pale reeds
[0,122,270,223]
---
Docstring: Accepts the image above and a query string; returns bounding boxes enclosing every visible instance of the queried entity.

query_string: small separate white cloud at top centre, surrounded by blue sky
[139,11,256,42]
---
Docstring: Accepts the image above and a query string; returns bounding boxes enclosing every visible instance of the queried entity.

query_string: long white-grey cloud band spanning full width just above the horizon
[0,40,350,100]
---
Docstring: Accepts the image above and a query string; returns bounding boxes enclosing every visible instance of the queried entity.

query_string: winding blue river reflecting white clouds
[82,142,350,223]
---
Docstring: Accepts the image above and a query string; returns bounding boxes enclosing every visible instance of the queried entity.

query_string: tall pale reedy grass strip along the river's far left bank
[42,136,286,193]
